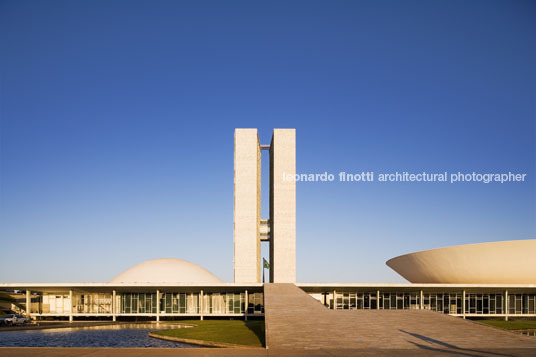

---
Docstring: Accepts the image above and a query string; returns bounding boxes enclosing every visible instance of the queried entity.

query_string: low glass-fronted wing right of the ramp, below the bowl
[302,284,536,317]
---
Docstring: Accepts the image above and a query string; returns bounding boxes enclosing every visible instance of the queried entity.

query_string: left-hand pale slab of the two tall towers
[234,129,261,283]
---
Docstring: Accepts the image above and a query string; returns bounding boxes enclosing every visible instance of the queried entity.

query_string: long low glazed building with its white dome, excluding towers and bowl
[0,259,536,321]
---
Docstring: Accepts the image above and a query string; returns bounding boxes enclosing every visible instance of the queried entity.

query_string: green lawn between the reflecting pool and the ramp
[155,320,264,347]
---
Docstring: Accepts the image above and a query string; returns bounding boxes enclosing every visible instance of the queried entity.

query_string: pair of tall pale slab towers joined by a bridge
[234,129,296,283]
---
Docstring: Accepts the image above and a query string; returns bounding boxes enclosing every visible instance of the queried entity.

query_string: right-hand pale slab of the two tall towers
[270,129,296,283]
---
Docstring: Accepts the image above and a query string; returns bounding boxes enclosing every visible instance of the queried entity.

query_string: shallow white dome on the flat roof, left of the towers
[110,258,222,284]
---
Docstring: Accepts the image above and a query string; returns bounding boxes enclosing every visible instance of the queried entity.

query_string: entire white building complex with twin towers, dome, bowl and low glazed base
[0,129,536,321]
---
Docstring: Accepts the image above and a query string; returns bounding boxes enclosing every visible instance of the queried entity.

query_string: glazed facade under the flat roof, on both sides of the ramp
[27,288,536,317]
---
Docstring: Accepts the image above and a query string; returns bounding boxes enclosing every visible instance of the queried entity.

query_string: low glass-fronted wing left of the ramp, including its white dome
[0,258,264,321]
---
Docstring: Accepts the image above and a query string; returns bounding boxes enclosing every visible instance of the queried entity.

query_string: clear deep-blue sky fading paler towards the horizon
[0,0,536,282]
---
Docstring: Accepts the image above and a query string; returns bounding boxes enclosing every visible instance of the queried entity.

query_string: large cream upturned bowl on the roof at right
[386,239,536,284]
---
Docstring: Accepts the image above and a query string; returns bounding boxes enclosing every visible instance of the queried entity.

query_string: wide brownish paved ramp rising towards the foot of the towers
[264,284,536,356]
